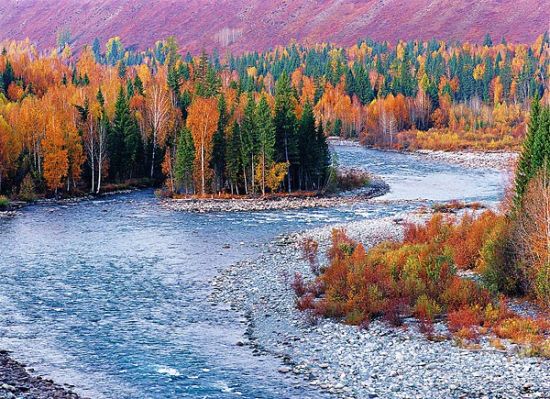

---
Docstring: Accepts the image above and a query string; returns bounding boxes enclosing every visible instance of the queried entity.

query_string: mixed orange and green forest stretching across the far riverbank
[0,32,550,199]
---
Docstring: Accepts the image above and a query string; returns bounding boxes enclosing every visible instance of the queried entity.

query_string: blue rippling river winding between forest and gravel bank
[0,146,506,399]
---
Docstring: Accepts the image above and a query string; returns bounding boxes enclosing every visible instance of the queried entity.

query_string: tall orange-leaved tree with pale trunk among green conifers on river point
[187,97,220,195]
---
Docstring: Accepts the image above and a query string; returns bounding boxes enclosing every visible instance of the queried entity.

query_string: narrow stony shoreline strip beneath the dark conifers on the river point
[162,179,389,213]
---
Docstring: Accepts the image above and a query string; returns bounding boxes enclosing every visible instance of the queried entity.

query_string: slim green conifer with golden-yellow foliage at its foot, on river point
[256,95,275,196]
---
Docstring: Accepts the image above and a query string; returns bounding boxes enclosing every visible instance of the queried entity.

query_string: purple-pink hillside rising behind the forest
[0,0,550,52]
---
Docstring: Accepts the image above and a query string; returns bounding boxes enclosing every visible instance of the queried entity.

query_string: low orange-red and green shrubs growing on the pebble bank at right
[296,211,550,354]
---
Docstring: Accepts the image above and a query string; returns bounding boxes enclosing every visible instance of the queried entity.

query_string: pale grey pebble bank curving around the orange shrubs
[210,214,550,399]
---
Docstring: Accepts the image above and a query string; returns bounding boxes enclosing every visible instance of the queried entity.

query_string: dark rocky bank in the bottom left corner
[0,351,81,399]
